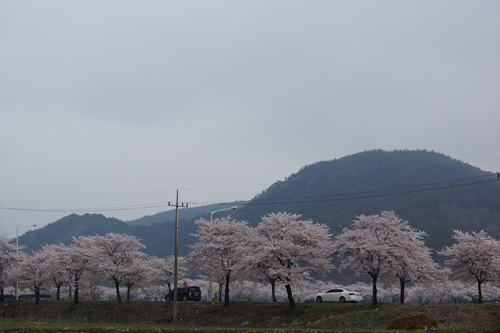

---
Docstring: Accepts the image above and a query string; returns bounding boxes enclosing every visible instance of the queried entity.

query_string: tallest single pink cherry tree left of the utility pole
[89,233,146,303]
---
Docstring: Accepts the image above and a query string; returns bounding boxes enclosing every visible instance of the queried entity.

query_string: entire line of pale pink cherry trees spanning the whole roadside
[0,211,500,307]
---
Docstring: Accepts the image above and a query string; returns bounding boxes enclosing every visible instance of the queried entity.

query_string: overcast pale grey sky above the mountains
[0,0,500,236]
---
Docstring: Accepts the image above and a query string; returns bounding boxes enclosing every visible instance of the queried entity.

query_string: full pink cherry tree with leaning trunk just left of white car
[252,213,333,308]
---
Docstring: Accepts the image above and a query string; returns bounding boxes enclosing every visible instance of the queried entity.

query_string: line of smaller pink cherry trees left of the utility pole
[0,233,187,304]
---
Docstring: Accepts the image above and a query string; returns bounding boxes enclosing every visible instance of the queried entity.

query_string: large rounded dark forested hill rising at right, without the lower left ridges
[230,150,500,249]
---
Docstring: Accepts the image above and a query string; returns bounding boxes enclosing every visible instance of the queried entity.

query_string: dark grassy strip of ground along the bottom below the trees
[0,301,500,333]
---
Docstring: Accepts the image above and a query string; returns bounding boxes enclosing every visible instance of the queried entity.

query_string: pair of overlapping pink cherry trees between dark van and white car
[190,213,333,307]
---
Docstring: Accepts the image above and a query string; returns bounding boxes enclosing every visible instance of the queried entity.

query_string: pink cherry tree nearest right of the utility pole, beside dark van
[189,216,251,306]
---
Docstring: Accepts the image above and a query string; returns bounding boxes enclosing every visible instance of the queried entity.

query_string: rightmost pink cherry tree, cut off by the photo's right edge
[439,230,500,304]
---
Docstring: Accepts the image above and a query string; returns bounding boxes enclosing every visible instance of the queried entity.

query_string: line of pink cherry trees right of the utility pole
[190,211,500,307]
